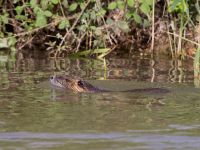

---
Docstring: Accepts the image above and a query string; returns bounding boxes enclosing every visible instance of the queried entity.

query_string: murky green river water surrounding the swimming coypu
[0,58,200,150]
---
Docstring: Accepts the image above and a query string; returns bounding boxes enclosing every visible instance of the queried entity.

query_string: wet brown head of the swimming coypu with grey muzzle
[50,75,98,92]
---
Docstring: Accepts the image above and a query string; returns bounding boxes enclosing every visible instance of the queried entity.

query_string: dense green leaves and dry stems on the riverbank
[0,0,200,57]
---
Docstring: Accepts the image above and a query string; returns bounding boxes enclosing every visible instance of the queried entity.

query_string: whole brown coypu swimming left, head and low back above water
[50,75,169,93]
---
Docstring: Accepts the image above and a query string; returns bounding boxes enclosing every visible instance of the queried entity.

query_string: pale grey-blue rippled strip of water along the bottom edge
[0,131,200,150]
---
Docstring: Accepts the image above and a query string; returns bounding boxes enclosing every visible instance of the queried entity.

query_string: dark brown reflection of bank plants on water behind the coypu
[0,55,194,82]
